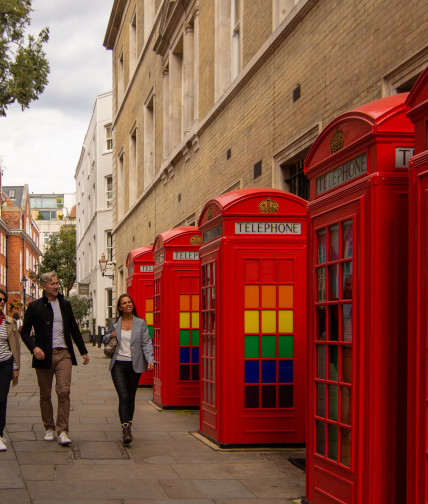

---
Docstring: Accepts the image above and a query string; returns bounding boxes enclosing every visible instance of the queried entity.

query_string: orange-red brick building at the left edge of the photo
[0,184,42,316]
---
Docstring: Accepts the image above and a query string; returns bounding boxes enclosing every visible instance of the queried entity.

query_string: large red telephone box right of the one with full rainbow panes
[305,94,413,504]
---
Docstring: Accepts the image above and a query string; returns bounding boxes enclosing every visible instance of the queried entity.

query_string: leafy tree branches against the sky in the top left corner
[0,0,50,116]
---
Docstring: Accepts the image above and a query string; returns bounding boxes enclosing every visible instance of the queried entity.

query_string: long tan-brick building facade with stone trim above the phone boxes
[104,0,428,293]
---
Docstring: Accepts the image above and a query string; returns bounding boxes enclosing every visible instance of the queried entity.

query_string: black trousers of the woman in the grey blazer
[111,361,141,424]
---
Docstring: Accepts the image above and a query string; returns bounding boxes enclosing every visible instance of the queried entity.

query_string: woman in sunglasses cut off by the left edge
[0,289,21,451]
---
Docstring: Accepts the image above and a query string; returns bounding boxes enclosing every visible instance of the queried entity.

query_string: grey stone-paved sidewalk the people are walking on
[0,344,305,504]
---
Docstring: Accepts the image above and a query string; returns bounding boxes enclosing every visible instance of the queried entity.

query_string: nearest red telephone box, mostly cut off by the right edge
[406,68,428,504]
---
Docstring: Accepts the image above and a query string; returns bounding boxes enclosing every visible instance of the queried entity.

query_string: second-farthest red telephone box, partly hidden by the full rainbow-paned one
[153,226,201,408]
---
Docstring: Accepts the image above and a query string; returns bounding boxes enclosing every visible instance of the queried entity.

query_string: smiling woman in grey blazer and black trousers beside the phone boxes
[104,294,153,444]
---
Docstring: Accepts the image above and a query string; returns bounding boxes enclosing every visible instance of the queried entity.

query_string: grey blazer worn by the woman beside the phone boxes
[103,315,153,373]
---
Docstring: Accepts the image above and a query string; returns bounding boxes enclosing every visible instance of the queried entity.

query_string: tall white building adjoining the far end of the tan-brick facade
[74,92,113,329]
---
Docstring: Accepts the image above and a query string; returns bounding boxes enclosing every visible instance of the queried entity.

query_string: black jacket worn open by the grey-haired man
[21,294,88,369]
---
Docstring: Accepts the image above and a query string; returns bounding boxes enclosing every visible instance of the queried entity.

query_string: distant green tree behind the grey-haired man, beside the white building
[40,223,76,297]
